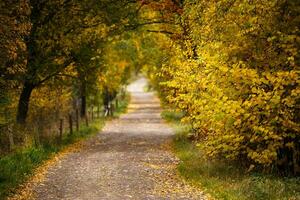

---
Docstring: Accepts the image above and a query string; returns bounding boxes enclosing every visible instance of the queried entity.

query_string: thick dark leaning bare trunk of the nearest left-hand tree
[17,81,35,124]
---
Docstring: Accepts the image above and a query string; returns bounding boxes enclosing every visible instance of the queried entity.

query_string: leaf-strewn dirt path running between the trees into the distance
[34,78,206,200]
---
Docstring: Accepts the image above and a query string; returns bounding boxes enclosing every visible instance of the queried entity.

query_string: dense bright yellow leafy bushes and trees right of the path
[148,0,300,173]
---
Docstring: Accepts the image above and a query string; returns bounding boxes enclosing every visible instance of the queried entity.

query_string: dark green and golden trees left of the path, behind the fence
[0,0,137,155]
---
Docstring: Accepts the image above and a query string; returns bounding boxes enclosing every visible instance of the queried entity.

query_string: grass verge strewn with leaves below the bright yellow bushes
[162,111,300,200]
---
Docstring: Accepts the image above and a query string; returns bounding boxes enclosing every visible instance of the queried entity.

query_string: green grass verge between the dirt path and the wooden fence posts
[0,95,129,199]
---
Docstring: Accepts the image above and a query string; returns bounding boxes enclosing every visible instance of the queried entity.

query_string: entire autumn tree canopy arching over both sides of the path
[0,0,300,173]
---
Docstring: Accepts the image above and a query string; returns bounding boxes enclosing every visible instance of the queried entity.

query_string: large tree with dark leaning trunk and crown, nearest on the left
[17,0,141,123]
